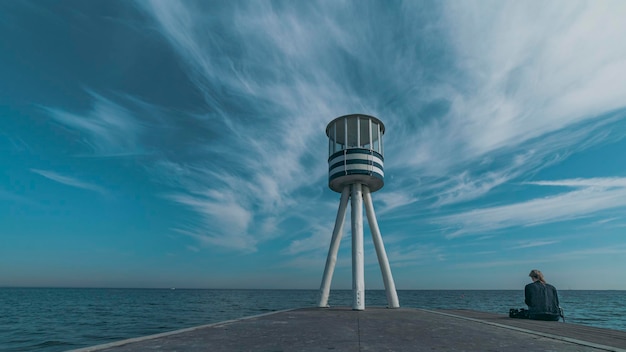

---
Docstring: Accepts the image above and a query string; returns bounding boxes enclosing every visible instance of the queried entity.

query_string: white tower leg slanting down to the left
[318,185,350,307]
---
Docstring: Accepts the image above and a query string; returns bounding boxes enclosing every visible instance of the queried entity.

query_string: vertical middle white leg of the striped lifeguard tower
[350,183,365,310]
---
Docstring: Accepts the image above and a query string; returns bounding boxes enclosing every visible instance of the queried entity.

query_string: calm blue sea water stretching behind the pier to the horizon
[0,288,626,352]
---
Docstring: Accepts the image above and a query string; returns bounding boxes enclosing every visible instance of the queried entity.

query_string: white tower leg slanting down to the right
[363,185,400,308]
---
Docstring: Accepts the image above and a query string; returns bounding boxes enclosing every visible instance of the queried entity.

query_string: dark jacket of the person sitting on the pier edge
[524,281,560,320]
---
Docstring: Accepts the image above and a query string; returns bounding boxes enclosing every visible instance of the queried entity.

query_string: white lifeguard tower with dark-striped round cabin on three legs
[319,114,400,310]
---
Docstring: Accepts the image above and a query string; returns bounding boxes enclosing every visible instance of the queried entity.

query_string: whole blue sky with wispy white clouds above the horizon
[0,0,626,289]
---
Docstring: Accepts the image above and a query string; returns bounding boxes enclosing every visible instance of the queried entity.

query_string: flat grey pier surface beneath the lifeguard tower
[70,307,626,352]
